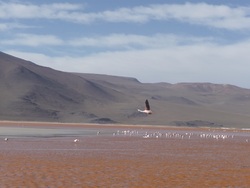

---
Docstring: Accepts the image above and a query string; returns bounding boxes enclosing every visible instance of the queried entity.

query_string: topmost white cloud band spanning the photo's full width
[0,2,250,30]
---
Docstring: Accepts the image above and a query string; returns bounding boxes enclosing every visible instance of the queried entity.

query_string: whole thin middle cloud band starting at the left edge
[0,33,215,50]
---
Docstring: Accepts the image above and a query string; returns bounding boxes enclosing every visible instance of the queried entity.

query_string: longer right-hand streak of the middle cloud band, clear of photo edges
[68,33,214,49]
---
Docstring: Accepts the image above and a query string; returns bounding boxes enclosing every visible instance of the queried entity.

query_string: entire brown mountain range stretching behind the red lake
[0,52,250,128]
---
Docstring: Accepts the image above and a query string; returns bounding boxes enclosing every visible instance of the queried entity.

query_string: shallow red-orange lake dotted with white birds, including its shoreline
[0,121,250,188]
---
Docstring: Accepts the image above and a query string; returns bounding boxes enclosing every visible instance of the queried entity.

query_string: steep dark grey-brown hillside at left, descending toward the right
[0,53,128,120]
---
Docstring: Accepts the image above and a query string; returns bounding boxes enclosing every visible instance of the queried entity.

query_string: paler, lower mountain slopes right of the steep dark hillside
[78,74,250,127]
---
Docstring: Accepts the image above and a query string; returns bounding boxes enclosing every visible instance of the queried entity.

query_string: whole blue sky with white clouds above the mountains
[0,0,250,88]
